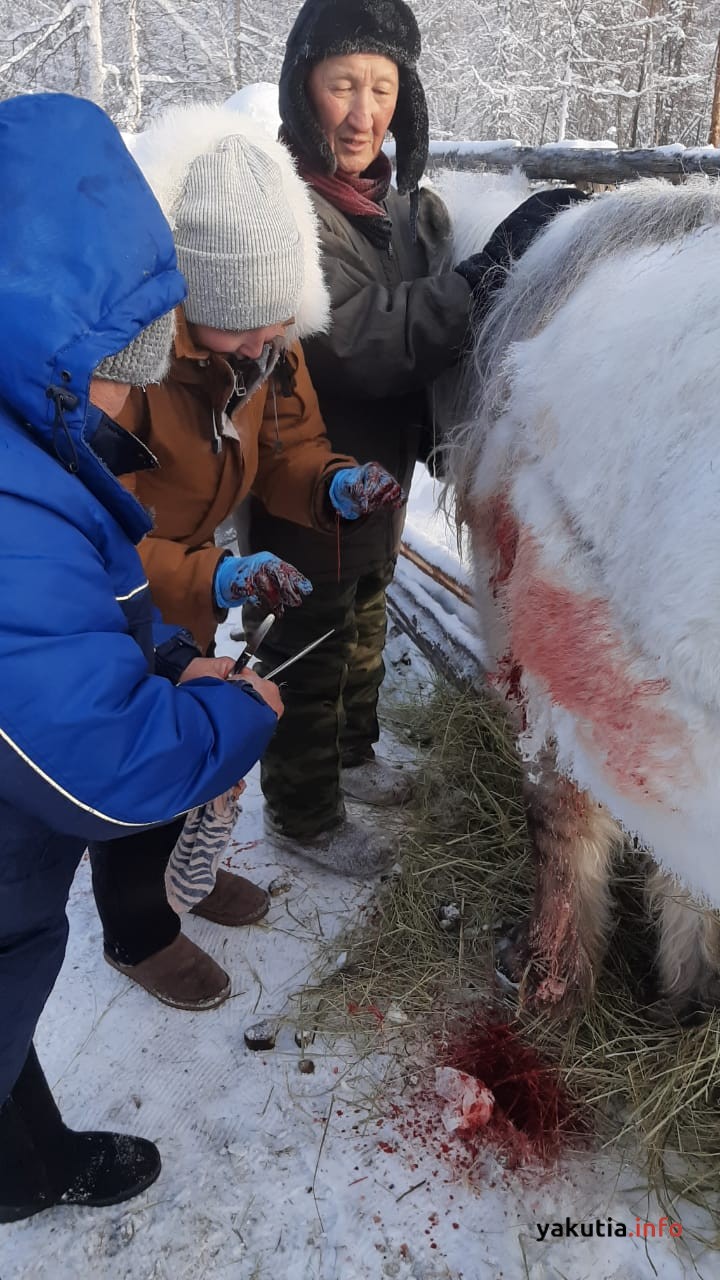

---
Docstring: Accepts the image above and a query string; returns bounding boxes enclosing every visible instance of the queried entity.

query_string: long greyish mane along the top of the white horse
[443,177,720,507]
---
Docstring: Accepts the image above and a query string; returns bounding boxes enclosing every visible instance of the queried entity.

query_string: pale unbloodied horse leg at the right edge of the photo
[647,867,720,1019]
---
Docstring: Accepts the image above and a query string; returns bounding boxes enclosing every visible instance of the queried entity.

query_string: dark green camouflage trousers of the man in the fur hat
[243,561,395,838]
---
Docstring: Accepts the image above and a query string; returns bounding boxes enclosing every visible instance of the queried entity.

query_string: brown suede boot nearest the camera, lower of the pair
[105,933,231,1010]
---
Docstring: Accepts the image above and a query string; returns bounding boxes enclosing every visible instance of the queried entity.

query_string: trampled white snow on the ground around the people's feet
[0,483,720,1280]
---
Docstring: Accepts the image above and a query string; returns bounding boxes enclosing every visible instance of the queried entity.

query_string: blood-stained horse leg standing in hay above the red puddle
[521,751,620,1015]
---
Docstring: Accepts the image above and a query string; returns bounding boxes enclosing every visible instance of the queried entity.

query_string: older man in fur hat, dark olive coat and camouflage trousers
[249,0,471,876]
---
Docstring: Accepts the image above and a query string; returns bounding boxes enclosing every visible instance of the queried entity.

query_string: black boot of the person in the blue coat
[0,1046,160,1222]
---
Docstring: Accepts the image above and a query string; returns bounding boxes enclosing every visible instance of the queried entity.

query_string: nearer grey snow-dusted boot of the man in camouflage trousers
[265,817,397,879]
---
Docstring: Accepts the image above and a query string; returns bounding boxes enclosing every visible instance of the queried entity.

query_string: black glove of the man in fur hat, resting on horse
[455,187,588,308]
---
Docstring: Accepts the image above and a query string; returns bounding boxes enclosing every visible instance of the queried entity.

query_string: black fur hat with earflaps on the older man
[279,0,428,195]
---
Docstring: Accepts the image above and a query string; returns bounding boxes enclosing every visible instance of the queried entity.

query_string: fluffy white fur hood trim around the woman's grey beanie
[133,102,331,338]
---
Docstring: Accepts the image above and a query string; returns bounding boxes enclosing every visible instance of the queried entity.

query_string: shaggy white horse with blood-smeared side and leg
[441,170,720,1014]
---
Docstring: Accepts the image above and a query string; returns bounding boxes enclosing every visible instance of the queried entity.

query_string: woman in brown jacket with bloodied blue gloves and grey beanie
[91,106,402,1009]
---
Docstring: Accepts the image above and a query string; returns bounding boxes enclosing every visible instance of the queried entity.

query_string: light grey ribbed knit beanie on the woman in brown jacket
[173,134,304,333]
